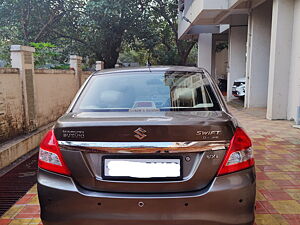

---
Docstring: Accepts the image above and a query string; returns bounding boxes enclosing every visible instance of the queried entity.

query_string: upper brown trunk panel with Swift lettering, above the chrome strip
[54,111,235,142]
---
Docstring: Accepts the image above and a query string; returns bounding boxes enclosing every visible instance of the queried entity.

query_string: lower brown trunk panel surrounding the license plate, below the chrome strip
[62,150,225,193]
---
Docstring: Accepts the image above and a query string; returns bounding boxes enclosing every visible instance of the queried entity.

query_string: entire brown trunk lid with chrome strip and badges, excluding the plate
[54,111,234,193]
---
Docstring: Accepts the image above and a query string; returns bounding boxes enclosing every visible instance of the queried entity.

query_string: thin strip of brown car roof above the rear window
[93,66,204,75]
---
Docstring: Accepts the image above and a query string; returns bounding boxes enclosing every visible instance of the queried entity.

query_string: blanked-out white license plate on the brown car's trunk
[103,158,181,179]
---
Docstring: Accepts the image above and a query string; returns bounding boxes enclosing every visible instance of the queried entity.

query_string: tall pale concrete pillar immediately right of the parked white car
[245,1,272,108]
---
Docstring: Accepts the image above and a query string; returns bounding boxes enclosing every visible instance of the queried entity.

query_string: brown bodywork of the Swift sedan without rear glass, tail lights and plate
[38,66,255,225]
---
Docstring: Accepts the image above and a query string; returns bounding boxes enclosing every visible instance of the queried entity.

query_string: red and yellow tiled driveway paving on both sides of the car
[0,105,300,225]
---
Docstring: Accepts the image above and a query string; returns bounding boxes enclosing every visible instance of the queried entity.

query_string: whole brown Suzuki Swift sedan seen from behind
[38,67,255,225]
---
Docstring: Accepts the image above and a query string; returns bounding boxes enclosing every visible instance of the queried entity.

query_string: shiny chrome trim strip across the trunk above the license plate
[58,141,229,153]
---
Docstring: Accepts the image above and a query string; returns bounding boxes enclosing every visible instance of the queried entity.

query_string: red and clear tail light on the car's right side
[218,128,254,175]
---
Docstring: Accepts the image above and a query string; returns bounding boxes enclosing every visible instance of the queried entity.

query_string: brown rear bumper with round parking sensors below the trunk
[38,168,256,225]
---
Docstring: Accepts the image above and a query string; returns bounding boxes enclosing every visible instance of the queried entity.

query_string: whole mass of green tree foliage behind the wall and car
[0,0,195,67]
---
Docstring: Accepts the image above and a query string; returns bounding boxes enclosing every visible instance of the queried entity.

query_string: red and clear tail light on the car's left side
[38,130,71,175]
